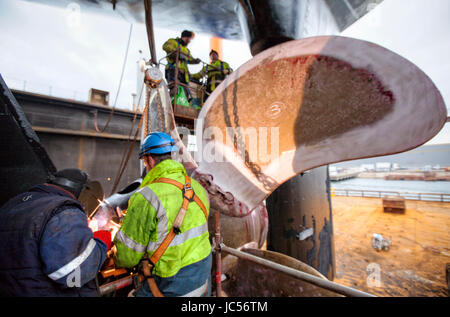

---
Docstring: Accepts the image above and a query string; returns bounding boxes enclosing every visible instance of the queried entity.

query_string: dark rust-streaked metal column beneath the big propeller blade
[266,167,336,280]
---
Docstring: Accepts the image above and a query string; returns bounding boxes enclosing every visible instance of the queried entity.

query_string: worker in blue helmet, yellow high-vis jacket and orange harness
[114,132,211,297]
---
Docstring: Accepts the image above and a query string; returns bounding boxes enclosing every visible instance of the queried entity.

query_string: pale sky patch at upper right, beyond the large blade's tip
[342,0,450,144]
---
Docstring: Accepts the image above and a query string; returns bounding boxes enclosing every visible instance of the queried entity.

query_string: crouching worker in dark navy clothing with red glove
[0,169,111,296]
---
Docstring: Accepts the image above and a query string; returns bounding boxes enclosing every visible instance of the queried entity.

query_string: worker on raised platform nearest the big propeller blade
[192,50,233,102]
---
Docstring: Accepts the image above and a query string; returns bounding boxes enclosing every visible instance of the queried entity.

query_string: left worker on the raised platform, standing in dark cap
[163,30,200,100]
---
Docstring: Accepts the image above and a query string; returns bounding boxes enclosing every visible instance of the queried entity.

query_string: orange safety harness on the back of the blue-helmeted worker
[141,175,208,297]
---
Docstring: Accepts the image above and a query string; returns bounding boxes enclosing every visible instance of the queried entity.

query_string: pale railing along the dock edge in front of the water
[331,188,450,202]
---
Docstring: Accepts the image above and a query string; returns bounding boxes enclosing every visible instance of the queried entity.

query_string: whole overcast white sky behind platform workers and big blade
[0,0,450,143]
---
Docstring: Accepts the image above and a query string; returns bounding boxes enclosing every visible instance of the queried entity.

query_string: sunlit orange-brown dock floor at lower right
[332,197,450,296]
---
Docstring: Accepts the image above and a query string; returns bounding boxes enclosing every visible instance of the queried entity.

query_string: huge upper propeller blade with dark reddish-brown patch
[196,36,447,215]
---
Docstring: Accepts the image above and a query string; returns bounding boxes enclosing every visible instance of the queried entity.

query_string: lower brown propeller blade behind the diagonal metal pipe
[222,249,341,297]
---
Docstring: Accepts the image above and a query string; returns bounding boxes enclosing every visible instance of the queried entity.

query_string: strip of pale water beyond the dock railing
[331,178,450,194]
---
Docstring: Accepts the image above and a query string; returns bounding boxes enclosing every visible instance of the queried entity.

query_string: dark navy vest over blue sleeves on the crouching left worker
[0,185,102,296]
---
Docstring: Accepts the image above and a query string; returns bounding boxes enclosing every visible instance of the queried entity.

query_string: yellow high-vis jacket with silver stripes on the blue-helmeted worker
[114,159,211,277]
